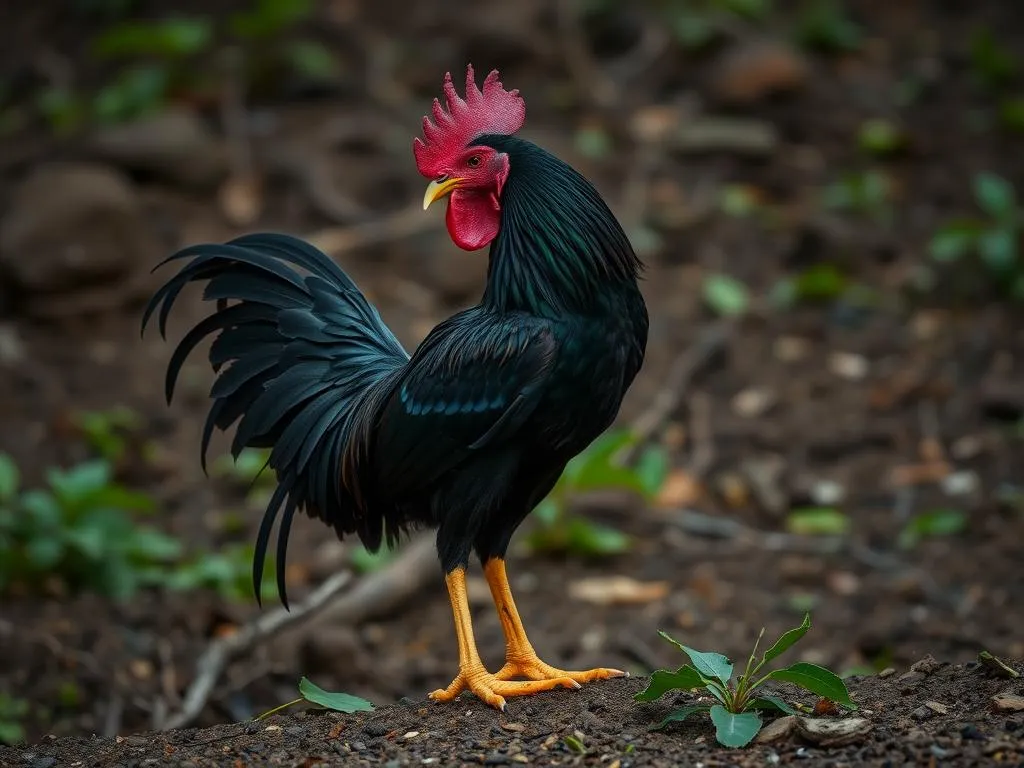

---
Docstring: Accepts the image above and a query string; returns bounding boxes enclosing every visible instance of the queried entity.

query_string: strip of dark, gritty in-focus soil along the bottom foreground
[0,665,1024,768]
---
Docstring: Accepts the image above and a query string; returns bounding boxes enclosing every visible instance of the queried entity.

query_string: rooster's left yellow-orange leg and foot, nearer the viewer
[430,568,580,711]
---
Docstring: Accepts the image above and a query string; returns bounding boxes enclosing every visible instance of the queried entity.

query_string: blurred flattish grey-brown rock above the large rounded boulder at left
[91,110,227,188]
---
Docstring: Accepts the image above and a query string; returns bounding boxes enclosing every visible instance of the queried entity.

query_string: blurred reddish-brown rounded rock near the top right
[711,40,808,104]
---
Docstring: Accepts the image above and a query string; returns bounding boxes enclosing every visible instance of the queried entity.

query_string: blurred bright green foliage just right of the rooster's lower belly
[526,431,669,556]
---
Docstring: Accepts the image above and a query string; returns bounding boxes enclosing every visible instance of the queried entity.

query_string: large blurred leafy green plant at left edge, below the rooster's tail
[0,455,181,598]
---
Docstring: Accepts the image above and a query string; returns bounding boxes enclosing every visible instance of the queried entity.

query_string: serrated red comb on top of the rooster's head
[413,65,526,178]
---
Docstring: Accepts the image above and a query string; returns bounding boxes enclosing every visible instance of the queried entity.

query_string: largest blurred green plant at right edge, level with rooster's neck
[929,173,1024,299]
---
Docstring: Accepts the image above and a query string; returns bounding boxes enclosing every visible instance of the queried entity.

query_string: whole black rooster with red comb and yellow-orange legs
[142,66,648,710]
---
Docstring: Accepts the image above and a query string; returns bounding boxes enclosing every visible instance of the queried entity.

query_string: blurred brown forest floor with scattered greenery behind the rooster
[0,0,1024,741]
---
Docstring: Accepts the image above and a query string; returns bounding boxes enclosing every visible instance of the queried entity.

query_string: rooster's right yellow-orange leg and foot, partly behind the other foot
[483,557,626,683]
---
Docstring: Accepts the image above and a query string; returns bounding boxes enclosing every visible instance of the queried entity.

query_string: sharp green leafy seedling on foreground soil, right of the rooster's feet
[636,613,857,748]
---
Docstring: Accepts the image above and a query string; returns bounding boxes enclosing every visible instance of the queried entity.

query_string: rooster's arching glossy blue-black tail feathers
[142,233,409,606]
